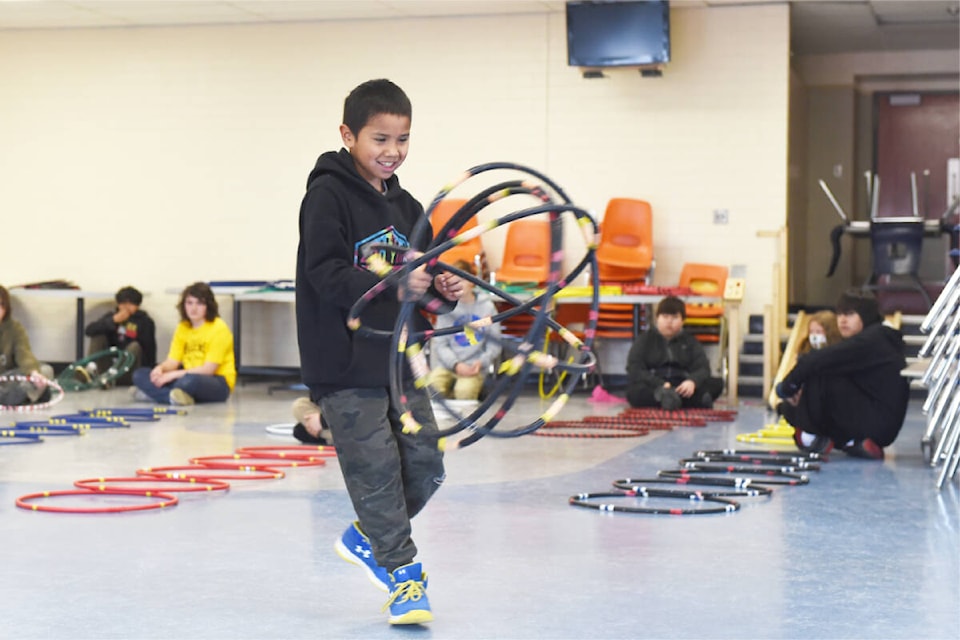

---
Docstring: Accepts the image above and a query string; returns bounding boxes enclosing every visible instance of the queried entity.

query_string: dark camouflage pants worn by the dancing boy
[319,388,444,571]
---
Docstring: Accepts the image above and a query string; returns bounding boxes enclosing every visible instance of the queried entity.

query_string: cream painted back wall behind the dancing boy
[0,5,789,365]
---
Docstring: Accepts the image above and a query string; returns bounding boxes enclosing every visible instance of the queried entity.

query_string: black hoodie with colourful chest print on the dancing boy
[296,149,430,395]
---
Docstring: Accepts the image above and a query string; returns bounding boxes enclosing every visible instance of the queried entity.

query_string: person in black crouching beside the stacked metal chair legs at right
[776,289,910,460]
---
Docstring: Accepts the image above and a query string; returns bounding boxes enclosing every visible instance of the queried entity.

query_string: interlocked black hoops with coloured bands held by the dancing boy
[347,163,600,447]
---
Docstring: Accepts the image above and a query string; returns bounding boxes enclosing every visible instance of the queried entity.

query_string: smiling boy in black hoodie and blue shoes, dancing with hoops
[296,80,463,624]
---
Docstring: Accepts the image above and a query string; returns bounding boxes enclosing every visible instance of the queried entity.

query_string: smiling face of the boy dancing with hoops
[340,113,410,192]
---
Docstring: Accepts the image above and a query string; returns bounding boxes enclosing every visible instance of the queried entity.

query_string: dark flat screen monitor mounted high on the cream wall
[567,0,670,67]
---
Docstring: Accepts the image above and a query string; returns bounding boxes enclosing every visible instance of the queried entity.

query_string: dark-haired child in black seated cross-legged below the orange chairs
[627,296,723,411]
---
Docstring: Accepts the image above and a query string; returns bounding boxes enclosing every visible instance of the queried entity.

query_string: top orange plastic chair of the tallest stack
[597,198,655,284]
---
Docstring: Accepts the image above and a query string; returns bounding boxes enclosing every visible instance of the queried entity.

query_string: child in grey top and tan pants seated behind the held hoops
[430,260,501,400]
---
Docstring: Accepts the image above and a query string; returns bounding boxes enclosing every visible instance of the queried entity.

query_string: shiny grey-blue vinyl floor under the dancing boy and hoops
[0,383,960,639]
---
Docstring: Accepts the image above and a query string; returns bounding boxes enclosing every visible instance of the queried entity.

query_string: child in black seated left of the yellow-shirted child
[84,287,157,386]
